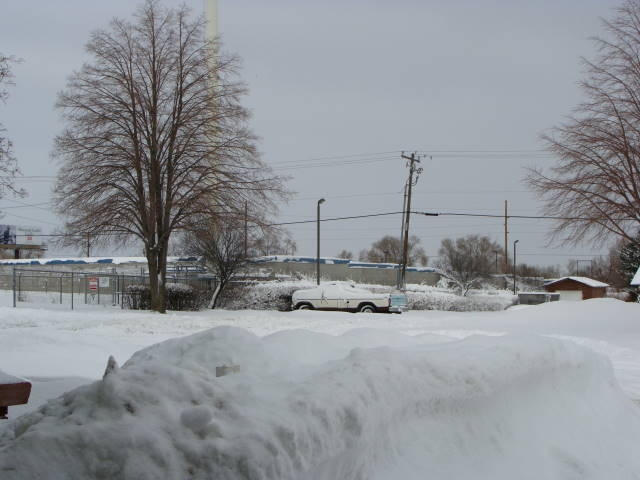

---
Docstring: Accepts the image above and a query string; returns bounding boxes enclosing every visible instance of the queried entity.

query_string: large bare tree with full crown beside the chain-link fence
[54,0,282,312]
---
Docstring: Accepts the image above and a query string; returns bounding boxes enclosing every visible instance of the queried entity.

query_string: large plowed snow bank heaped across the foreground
[0,327,640,480]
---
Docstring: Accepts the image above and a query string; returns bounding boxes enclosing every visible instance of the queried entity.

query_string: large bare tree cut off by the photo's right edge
[527,0,640,244]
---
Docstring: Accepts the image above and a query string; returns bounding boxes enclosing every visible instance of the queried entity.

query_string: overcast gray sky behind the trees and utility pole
[0,0,618,266]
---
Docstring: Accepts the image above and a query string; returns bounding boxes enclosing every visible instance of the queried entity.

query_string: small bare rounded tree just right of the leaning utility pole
[437,235,502,295]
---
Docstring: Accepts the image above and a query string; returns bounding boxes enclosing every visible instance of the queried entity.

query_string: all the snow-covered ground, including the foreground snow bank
[0,293,640,480]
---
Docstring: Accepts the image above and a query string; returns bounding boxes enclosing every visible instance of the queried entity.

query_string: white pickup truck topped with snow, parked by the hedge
[292,283,407,313]
